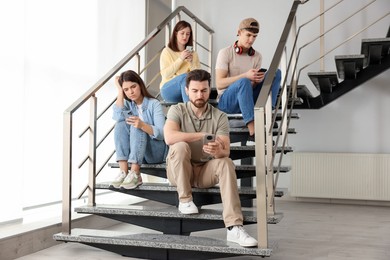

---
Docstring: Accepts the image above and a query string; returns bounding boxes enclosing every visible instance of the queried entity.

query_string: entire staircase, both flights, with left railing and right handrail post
[53,1,390,259]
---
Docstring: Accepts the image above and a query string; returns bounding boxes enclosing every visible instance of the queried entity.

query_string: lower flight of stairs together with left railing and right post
[53,3,299,259]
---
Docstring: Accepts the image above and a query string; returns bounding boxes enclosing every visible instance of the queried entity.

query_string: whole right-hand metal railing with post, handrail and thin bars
[255,0,390,248]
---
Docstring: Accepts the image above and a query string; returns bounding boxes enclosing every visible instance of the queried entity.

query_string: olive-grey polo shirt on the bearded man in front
[167,102,229,162]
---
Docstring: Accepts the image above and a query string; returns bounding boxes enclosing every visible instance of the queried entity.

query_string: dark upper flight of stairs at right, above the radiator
[294,26,390,109]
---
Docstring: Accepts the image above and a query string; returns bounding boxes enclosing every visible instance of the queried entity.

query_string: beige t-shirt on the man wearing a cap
[215,46,263,96]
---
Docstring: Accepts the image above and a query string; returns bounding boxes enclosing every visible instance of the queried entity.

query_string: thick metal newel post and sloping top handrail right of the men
[254,0,306,248]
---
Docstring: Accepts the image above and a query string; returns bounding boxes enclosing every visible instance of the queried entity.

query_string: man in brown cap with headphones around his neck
[215,18,281,138]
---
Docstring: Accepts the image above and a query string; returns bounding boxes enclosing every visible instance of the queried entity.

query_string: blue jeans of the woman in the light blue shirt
[114,121,168,165]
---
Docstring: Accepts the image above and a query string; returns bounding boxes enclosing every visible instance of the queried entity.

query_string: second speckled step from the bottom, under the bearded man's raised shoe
[75,204,283,235]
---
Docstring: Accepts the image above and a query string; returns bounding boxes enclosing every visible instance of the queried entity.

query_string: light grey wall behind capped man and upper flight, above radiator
[177,0,390,187]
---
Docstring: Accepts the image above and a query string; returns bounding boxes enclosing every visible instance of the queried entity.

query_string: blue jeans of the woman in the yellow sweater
[161,73,189,102]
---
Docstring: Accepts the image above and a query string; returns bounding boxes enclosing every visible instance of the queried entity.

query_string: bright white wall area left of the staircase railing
[0,0,145,222]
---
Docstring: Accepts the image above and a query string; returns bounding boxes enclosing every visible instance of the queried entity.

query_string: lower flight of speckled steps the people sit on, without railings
[54,89,299,259]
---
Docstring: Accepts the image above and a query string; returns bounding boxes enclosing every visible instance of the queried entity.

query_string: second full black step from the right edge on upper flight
[335,54,365,79]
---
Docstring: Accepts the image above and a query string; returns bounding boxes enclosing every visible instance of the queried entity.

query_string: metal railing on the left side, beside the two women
[62,6,214,234]
